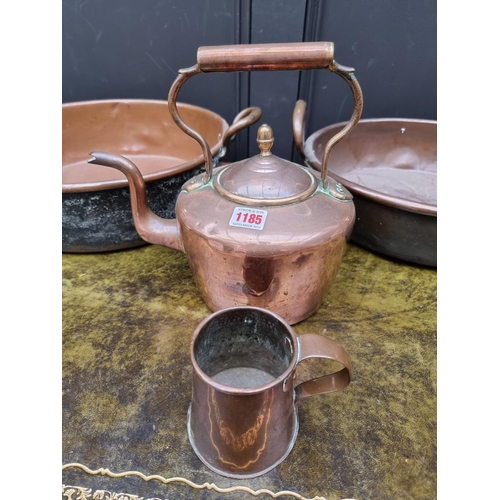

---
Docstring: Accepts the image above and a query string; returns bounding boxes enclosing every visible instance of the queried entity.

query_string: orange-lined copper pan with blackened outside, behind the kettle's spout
[62,99,261,253]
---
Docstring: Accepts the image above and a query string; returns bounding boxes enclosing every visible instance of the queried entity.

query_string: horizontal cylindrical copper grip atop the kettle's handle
[197,42,333,73]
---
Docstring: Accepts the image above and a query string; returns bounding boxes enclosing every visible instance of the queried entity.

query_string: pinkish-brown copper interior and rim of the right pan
[296,116,437,216]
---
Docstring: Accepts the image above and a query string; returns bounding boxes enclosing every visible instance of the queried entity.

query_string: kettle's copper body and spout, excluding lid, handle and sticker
[91,152,355,324]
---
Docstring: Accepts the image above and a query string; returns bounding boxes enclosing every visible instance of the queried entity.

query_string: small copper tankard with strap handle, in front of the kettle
[188,307,352,478]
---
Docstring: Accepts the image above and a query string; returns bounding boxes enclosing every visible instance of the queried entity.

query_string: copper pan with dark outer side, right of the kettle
[293,101,437,267]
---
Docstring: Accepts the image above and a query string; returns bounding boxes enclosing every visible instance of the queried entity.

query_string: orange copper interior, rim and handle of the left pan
[62,99,260,193]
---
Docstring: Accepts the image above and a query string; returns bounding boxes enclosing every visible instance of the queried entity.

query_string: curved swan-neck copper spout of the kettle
[88,151,184,251]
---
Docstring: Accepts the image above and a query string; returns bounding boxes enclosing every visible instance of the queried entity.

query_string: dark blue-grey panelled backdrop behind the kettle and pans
[62,0,437,161]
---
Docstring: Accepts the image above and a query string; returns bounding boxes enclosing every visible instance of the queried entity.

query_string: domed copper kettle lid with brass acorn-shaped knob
[214,124,318,206]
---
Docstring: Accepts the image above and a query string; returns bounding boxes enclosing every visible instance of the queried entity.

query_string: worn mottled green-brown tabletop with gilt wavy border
[62,244,437,500]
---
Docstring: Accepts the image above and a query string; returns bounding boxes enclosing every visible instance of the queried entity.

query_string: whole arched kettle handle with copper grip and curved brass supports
[168,42,363,187]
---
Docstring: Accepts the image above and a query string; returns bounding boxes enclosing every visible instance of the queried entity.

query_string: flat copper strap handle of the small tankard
[295,333,352,401]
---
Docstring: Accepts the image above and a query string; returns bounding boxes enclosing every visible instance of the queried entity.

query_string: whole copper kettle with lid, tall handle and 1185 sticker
[89,42,363,324]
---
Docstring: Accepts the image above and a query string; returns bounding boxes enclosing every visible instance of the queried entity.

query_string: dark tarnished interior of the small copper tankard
[194,308,293,387]
